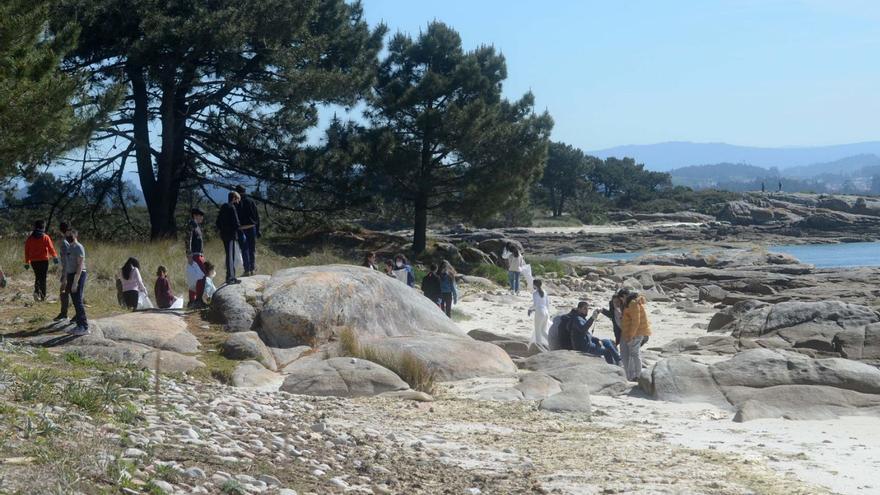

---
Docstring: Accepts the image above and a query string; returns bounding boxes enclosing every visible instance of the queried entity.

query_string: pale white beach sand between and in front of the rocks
[458,282,880,494]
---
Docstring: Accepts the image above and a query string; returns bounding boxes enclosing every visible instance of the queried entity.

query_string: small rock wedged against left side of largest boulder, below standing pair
[209,275,269,332]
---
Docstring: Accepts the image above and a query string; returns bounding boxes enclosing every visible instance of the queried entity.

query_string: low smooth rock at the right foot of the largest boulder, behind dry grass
[362,335,516,381]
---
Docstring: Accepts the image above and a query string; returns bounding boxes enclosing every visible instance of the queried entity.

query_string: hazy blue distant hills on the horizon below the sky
[589,141,880,172]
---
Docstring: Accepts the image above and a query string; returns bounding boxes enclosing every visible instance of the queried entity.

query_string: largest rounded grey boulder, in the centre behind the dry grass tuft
[259,265,464,347]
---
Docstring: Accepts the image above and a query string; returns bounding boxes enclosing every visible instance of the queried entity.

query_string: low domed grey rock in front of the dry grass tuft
[281,357,409,397]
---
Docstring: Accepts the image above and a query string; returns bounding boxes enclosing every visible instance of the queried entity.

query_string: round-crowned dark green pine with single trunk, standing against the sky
[367,22,553,253]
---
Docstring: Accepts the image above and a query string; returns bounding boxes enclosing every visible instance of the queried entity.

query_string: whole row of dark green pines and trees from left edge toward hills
[0,0,670,252]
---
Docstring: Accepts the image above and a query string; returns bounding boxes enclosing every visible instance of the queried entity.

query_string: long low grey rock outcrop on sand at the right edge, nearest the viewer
[640,349,880,421]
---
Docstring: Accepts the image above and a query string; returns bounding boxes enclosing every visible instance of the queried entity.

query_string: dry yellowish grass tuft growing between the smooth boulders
[339,328,436,394]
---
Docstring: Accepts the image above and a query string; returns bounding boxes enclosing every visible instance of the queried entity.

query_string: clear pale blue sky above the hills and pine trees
[363,0,880,150]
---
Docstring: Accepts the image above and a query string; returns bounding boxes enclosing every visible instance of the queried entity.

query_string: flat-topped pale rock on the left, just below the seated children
[92,311,199,354]
